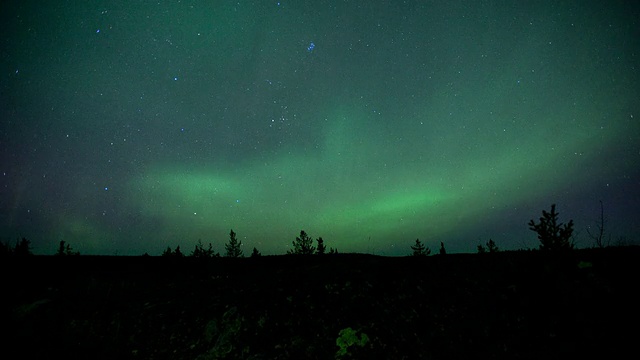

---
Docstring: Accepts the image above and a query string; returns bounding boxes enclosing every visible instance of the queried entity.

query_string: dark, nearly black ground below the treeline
[0,247,640,359]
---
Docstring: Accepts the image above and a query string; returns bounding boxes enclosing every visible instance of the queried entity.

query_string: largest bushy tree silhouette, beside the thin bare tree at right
[529,204,573,251]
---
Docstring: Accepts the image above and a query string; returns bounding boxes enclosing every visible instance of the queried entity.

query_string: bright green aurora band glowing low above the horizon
[126,98,624,253]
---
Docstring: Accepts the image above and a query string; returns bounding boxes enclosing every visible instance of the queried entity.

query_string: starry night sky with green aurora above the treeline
[0,0,640,255]
